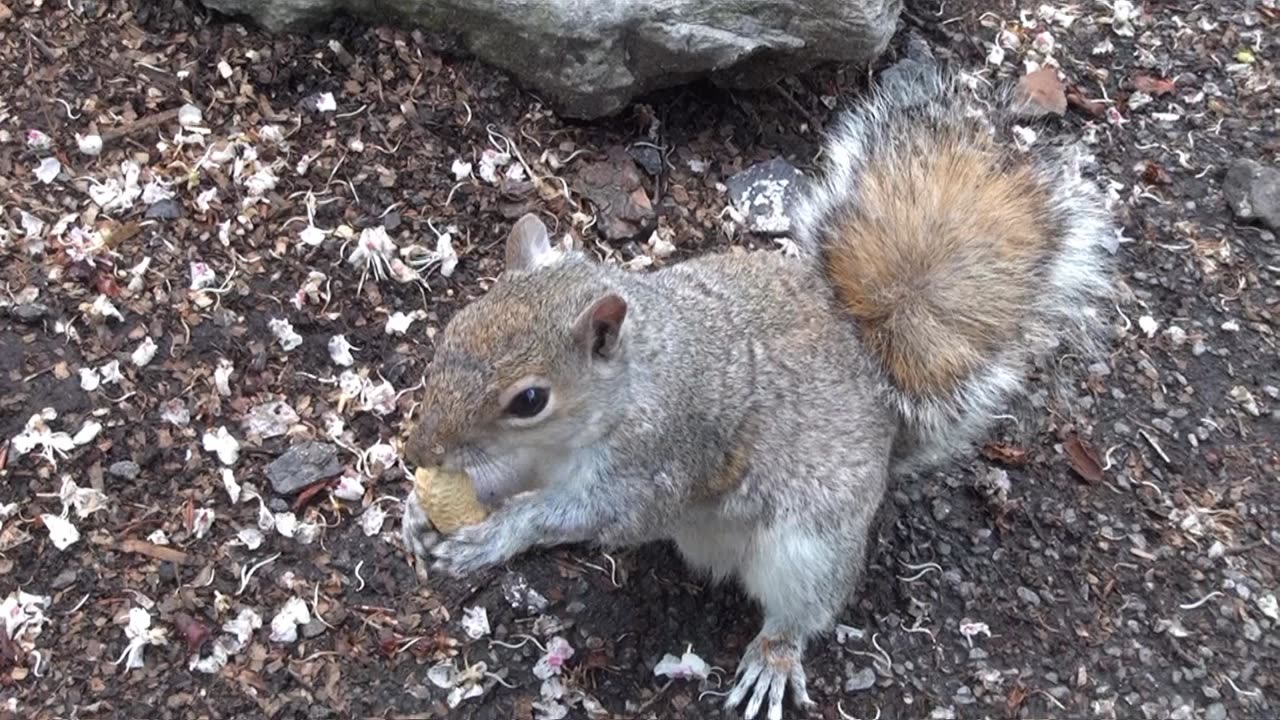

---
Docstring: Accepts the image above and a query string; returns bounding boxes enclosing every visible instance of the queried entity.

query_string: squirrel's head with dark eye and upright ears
[406,214,628,502]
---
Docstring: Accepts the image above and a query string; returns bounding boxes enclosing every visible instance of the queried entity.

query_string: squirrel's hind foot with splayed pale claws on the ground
[724,633,814,720]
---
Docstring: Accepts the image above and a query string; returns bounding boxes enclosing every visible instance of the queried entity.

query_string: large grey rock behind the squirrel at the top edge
[202,0,902,119]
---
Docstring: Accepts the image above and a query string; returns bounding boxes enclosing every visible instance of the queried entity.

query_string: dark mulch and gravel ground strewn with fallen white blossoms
[0,0,1280,720]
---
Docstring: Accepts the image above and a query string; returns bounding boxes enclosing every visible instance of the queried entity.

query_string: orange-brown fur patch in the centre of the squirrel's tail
[824,133,1057,400]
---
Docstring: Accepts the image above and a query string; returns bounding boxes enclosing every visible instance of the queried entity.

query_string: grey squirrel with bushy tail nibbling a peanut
[402,64,1115,720]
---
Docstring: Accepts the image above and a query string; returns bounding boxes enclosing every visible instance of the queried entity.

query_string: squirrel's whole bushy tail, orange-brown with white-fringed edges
[796,68,1115,470]
